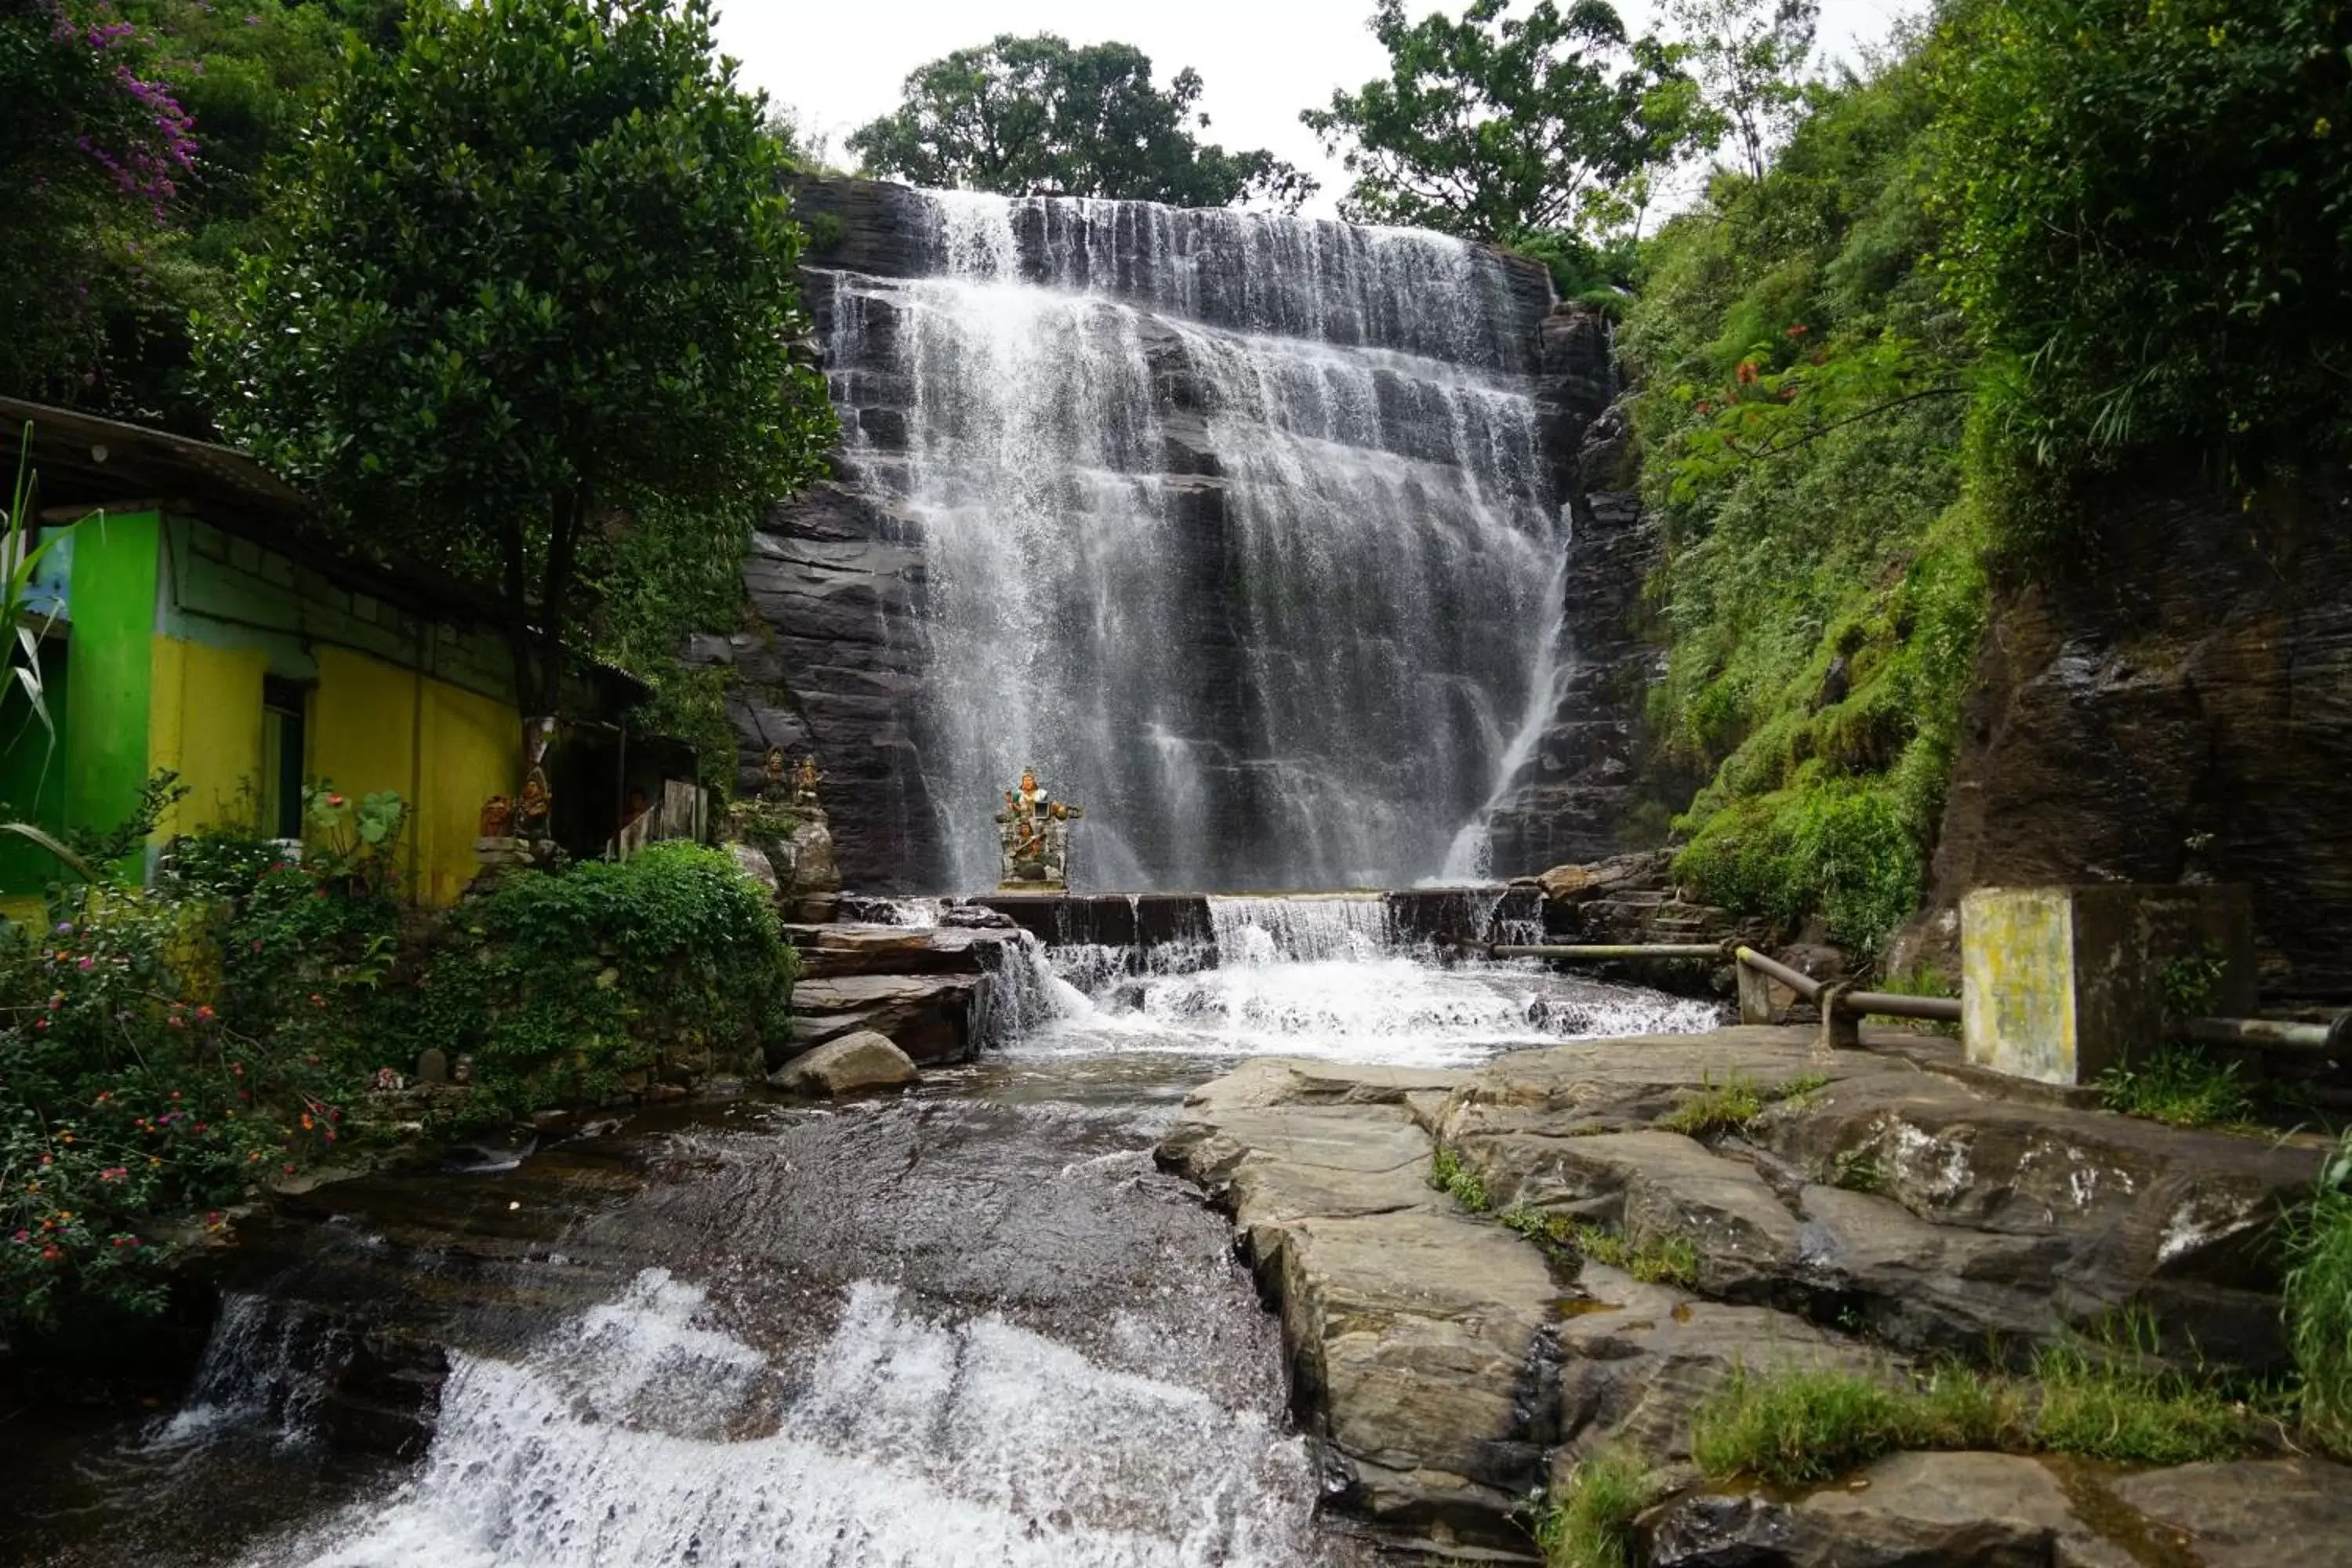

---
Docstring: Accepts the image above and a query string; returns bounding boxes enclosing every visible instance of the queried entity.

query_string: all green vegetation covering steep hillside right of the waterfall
[1623,0,2352,952]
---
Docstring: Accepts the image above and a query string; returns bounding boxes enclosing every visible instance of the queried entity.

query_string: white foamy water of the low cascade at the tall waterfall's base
[1009,898,1722,1067]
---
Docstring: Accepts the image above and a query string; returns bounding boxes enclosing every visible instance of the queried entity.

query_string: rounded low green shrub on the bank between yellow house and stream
[409,844,795,1119]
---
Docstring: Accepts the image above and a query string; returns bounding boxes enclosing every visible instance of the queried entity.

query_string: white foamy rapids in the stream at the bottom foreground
[252,1269,1345,1568]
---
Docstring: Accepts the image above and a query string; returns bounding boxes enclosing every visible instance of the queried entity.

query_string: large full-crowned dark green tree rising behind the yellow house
[198,0,833,747]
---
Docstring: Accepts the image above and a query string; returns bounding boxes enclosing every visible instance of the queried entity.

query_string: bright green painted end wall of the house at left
[59,513,160,865]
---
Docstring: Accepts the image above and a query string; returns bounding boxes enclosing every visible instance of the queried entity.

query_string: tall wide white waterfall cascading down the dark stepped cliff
[823,193,1564,888]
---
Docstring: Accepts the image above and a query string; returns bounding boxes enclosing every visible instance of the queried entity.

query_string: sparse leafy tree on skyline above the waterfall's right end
[1301,0,1700,240]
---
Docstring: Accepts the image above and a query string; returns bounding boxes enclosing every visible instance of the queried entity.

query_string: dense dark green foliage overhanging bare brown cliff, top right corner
[1922,0,2352,473]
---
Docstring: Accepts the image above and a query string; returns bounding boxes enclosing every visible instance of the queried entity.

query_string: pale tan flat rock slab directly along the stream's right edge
[1160,1058,1559,1549]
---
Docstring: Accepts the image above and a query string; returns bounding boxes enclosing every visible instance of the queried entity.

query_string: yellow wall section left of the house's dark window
[148,637,268,837]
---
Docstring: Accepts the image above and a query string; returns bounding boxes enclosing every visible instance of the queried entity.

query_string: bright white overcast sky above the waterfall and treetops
[717,0,1926,212]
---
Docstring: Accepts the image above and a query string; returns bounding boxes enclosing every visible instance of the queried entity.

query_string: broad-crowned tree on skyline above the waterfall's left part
[849,33,1315,212]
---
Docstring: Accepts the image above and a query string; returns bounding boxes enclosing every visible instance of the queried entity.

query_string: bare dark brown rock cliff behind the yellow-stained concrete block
[1912,473,2352,1001]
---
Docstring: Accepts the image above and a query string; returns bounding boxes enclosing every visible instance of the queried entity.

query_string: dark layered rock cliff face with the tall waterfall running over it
[734,179,1653,891]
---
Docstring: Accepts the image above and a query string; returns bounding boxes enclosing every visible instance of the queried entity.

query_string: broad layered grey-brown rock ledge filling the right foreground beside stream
[1160,1027,2352,1568]
